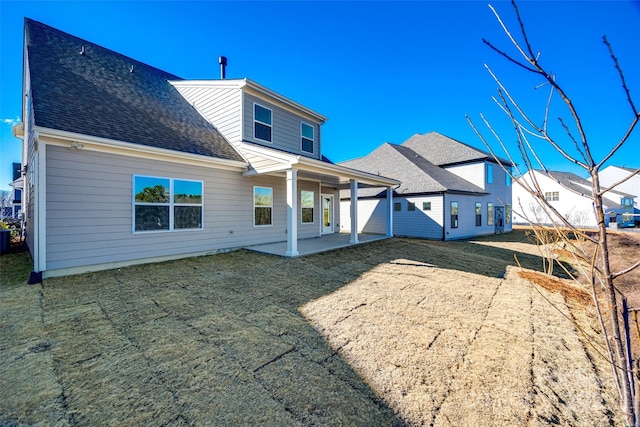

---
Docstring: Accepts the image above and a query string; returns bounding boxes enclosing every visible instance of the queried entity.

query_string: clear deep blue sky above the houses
[0,0,640,189]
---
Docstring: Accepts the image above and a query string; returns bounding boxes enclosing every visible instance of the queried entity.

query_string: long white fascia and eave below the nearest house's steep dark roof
[34,126,249,171]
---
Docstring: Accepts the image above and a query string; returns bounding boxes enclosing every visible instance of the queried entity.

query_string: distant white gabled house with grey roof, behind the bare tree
[513,170,634,228]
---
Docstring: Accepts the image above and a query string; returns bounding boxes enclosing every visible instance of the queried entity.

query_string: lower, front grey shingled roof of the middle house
[340,143,486,197]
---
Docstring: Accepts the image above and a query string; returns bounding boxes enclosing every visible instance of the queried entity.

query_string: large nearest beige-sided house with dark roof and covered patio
[14,19,398,277]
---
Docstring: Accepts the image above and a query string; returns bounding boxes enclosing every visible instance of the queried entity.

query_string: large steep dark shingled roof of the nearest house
[25,18,243,161]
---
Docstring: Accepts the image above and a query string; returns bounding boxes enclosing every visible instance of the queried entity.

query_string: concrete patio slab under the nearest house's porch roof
[244,233,390,256]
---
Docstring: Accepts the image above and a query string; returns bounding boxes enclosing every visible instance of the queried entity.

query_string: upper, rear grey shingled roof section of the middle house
[402,132,512,166]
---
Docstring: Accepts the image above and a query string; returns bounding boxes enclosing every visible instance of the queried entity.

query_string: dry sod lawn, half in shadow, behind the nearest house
[0,232,632,426]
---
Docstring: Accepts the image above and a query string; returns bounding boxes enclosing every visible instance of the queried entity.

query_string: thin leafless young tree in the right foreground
[467,1,640,426]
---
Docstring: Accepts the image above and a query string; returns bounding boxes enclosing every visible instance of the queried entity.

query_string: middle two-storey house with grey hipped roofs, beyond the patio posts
[340,132,512,240]
